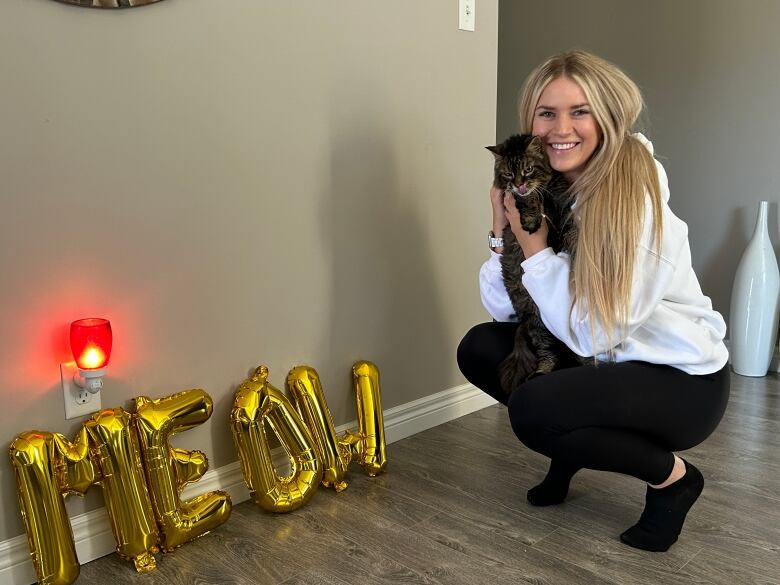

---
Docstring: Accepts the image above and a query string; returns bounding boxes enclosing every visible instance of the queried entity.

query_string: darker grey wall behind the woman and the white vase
[497,0,780,319]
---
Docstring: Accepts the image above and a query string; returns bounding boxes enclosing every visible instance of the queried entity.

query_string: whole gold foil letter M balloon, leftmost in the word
[11,408,163,583]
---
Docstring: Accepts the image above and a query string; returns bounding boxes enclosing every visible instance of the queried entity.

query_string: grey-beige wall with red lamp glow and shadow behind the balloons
[0,0,498,541]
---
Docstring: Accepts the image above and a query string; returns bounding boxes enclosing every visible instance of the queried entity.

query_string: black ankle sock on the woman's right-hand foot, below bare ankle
[620,459,704,552]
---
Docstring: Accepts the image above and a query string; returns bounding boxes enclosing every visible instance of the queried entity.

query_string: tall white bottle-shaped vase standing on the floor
[729,201,780,377]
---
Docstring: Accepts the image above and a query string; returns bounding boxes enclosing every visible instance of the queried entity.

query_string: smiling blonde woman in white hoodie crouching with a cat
[458,51,729,551]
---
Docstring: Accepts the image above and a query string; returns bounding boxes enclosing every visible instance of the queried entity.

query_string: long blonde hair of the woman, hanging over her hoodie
[519,51,662,357]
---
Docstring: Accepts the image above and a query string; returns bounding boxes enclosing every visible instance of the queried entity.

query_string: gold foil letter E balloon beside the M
[135,390,231,551]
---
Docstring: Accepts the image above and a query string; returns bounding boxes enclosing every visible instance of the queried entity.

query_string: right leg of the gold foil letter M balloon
[84,408,159,573]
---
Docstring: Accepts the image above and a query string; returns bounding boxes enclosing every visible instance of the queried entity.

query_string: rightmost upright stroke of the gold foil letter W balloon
[345,361,387,477]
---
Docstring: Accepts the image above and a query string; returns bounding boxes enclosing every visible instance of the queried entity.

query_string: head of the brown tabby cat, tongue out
[486,134,553,197]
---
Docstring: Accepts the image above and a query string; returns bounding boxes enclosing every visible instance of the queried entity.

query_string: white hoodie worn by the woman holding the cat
[479,134,728,374]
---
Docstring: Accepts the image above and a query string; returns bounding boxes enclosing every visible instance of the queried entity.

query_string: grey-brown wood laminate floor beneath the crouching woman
[77,374,780,585]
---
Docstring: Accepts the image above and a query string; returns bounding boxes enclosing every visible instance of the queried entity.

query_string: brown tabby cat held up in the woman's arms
[487,134,579,393]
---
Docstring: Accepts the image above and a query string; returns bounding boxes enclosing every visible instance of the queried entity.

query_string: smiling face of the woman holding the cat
[531,77,601,183]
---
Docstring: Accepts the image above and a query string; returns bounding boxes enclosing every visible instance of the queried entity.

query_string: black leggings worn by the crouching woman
[458,323,729,484]
